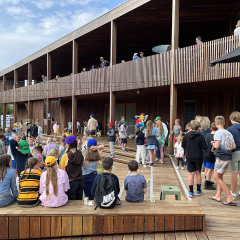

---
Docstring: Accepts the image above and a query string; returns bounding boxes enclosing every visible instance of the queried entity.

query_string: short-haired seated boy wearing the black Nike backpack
[91,157,120,207]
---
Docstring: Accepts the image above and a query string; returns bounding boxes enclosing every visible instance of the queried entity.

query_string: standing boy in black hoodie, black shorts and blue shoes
[182,120,207,198]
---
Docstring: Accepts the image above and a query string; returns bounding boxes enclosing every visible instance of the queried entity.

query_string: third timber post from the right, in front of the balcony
[71,40,78,135]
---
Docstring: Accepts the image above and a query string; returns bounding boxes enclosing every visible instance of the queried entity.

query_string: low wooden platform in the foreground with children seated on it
[0,200,205,239]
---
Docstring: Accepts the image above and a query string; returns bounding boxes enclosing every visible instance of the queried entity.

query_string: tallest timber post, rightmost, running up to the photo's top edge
[170,0,180,153]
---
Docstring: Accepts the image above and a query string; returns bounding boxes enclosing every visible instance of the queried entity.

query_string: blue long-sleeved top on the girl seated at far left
[0,168,18,197]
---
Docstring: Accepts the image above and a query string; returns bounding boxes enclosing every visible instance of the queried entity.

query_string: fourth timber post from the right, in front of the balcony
[46,53,52,135]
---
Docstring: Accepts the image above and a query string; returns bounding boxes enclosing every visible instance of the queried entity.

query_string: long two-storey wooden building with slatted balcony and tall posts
[0,0,240,133]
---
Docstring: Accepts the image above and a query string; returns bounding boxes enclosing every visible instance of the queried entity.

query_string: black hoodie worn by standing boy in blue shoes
[182,131,207,162]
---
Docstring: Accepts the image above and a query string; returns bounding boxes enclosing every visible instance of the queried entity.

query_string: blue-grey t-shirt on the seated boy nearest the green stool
[124,174,147,202]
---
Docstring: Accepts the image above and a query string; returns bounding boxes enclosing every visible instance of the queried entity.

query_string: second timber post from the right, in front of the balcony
[109,21,117,126]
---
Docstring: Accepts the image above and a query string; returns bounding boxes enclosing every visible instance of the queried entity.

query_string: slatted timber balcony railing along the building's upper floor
[0,36,240,103]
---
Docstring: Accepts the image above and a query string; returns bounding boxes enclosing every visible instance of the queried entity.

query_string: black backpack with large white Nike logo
[95,173,118,208]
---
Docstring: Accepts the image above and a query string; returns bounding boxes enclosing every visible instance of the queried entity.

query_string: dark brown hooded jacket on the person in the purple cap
[66,150,83,181]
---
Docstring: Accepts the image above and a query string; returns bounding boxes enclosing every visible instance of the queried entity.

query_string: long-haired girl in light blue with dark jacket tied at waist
[144,120,159,167]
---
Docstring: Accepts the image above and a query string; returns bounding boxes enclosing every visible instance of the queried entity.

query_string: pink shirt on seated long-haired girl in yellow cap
[39,168,70,207]
